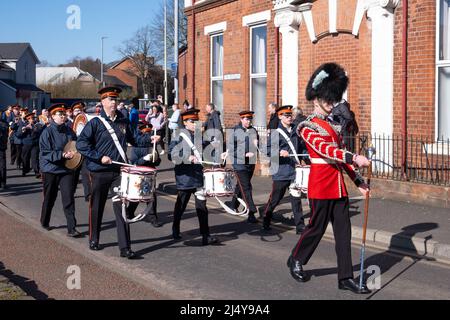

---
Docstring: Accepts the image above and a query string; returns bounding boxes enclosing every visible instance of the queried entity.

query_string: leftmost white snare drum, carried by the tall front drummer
[118,167,157,202]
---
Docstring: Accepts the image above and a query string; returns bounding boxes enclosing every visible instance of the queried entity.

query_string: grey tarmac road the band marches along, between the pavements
[0,162,450,300]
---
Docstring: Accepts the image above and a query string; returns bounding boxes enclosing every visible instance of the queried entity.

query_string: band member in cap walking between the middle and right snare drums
[227,110,259,223]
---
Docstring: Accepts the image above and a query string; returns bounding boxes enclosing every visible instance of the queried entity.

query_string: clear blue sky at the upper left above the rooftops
[0,0,163,65]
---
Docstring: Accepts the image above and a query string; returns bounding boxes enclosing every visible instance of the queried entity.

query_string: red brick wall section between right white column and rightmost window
[394,0,436,139]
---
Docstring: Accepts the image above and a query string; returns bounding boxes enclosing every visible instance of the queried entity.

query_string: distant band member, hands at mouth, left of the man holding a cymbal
[16,113,43,179]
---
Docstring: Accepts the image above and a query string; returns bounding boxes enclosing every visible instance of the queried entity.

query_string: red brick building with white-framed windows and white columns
[179,0,450,139]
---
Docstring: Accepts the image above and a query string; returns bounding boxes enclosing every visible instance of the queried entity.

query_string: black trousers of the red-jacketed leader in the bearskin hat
[292,198,353,280]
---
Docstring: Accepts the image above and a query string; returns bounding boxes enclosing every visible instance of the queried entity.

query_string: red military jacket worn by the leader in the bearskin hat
[297,114,364,199]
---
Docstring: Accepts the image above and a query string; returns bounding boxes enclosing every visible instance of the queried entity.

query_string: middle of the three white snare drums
[203,168,234,197]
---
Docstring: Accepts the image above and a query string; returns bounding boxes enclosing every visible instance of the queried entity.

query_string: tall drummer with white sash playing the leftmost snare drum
[77,87,160,259]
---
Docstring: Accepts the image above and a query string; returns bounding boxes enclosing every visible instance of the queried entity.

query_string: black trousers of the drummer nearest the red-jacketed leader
[264,180,305,227]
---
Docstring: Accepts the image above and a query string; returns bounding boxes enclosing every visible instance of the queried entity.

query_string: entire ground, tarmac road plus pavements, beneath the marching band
[0,153,450,300]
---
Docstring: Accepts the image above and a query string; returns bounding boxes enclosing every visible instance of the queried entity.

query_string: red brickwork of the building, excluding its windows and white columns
[180,0,436,137]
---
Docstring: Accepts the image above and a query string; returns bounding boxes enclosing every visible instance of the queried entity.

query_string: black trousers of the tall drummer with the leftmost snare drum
[88,172,131,250]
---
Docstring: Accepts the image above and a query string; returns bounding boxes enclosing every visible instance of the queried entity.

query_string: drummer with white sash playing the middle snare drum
[168,109,218,246]
